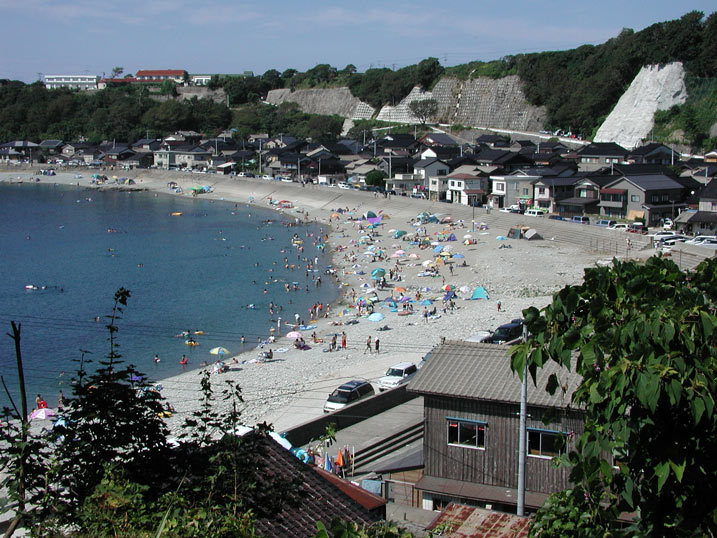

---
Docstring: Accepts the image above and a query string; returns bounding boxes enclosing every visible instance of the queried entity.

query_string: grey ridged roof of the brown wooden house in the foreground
[408,341,582,407]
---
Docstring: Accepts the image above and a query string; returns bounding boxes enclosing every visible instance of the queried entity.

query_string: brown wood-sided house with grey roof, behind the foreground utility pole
[408,341,585,512]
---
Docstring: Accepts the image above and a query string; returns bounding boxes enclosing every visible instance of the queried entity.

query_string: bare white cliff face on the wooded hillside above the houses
[595,62,687,149]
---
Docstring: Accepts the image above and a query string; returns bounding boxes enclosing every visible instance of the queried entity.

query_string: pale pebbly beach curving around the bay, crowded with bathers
[0,167,609,431]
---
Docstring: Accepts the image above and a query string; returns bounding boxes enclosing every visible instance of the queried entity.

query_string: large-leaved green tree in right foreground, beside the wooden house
[511,257,717,536]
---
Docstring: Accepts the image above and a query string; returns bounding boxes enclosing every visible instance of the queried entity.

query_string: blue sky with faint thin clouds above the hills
[0,0,715,82]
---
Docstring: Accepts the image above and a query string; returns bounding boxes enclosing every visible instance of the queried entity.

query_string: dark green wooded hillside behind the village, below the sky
[0,11,717,149]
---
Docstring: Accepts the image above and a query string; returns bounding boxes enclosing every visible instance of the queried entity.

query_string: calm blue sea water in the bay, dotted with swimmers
[0,183,338,406]
